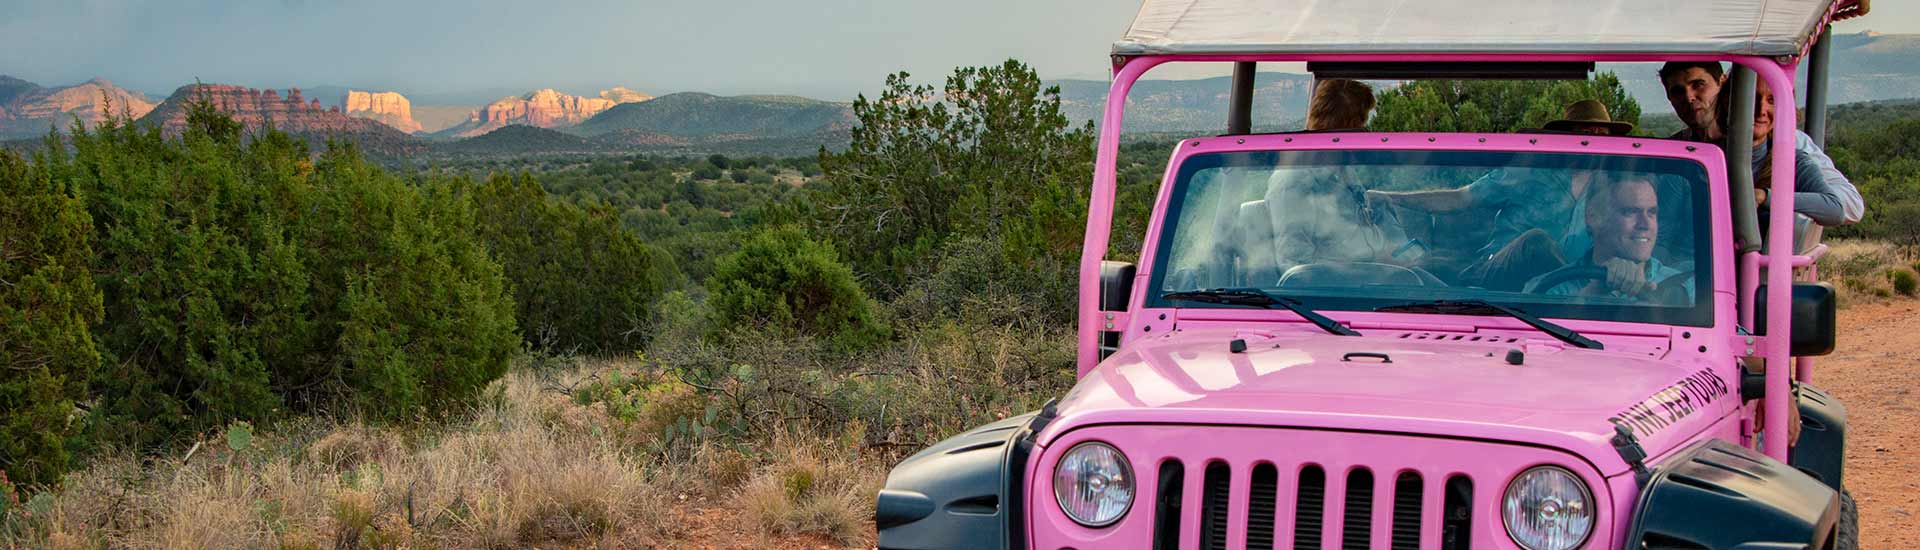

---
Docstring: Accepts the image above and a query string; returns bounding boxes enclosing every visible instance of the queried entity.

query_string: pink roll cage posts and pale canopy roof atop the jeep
[1077,0,1860,462]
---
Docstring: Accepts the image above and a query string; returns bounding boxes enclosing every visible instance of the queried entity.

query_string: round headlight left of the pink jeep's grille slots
[1054,440,1133,527]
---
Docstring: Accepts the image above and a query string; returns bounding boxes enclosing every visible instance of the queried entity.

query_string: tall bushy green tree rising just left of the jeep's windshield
[816,60,1094,292]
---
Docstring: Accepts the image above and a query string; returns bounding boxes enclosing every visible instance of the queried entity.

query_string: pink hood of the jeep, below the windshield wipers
[1041,331,1740,475]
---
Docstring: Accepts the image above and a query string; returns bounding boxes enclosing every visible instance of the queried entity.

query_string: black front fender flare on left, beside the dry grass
[874,402,1054,550]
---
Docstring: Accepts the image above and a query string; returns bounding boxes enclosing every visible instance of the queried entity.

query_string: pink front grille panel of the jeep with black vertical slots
[1033,425,1613,550]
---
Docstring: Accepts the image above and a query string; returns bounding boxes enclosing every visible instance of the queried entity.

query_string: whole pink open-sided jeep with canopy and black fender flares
[876,0,1855,550]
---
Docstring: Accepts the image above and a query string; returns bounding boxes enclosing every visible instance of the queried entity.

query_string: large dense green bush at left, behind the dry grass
[65,104,518,446]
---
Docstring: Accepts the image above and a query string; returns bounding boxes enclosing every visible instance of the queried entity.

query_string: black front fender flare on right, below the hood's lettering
[1624,440,1839,548]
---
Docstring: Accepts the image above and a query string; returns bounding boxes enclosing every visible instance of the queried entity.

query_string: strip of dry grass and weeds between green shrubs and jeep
[6,294,1071,548]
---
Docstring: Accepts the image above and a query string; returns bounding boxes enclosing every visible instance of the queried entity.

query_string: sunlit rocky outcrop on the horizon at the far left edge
[0,77,154,137]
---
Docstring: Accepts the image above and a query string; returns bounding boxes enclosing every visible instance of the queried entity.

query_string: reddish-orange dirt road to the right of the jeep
[1812,300,1920,550]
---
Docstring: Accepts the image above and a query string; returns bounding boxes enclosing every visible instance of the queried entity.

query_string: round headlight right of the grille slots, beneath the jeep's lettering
[1500,465,1594,550]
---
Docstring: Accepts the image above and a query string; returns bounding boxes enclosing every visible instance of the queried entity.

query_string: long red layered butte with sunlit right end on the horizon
[140,85,422,154]
